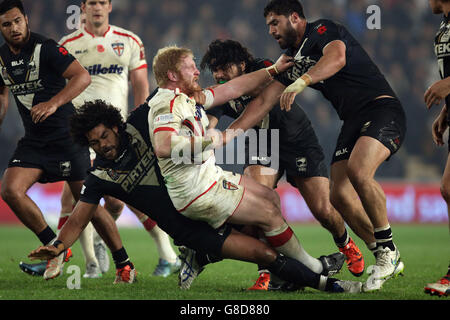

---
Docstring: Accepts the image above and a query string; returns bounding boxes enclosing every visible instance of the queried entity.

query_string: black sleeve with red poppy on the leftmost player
[41,40,75,75]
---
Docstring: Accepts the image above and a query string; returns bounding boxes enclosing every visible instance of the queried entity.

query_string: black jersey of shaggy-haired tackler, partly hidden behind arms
[206,59,311,144]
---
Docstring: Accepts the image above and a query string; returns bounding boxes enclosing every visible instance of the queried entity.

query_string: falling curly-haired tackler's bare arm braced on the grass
[28,201,98,260]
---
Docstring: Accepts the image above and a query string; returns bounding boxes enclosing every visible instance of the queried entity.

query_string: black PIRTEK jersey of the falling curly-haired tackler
[81,104,169,212]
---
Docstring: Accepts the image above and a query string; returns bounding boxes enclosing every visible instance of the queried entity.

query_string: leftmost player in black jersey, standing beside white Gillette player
[0,0,136,279]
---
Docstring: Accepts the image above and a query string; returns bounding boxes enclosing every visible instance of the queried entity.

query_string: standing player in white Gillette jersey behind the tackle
[20,0,180,278]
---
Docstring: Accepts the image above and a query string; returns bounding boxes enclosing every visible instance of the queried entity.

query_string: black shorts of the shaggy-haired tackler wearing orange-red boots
[244,127,328,188]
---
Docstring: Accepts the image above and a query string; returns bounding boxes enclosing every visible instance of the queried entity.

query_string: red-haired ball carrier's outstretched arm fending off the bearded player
[205,54,294,109]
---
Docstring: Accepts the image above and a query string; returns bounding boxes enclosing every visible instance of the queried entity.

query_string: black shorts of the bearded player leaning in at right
[331,98,406,163]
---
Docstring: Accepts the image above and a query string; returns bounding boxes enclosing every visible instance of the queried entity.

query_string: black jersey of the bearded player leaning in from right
[276,19,396,120]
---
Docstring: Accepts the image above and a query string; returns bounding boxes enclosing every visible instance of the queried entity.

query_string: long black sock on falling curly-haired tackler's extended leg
[267,255,320,289]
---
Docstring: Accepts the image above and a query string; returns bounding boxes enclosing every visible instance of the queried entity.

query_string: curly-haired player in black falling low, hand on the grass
[30,98,362,293]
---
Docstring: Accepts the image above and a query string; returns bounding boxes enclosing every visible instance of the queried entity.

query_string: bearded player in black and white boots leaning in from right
[214,0,406,291]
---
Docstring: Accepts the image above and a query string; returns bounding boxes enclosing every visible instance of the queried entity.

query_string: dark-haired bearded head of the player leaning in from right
[264,0,306,49]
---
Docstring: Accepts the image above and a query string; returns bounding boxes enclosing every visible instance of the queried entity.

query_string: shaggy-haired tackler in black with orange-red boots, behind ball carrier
[200,40,364,290]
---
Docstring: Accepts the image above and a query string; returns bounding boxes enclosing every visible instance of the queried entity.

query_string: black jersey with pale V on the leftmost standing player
[0,32,75,146]
